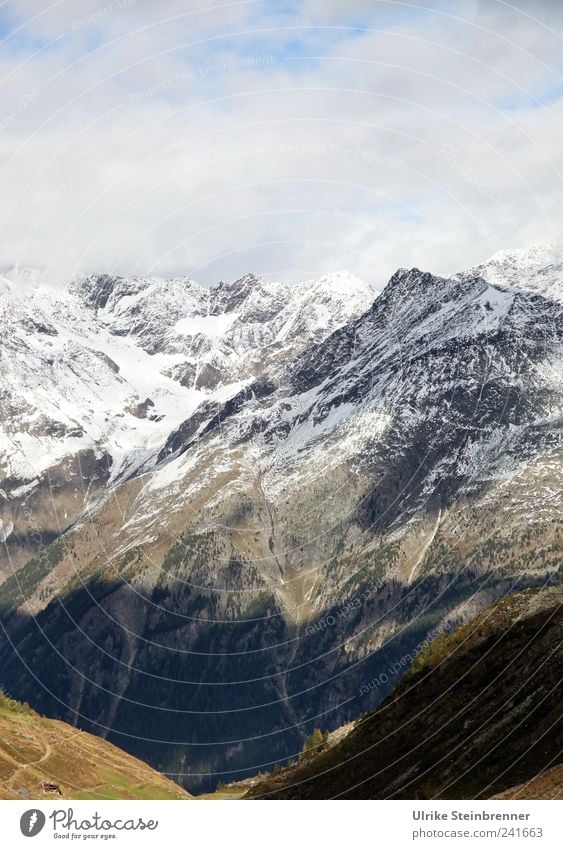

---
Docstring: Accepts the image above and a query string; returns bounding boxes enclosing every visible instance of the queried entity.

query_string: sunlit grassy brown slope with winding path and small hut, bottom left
[0,693,190,800]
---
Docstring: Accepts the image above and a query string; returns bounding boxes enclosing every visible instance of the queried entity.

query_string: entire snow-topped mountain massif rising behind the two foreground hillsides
[0,251,563,790]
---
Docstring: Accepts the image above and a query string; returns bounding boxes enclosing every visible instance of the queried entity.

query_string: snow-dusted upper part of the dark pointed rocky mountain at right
[128,269,563,584]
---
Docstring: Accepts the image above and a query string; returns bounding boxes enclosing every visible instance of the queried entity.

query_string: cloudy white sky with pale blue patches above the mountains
[0,0,563,287]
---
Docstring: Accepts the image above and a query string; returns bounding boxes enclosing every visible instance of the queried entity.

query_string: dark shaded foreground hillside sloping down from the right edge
[248,586,563,799]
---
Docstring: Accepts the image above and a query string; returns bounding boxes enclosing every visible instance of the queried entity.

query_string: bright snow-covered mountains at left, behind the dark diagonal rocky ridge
[0,268,374,567]
